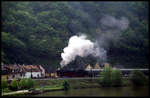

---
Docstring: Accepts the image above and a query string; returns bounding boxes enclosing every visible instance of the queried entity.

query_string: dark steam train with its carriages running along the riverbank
[57,69,149,77]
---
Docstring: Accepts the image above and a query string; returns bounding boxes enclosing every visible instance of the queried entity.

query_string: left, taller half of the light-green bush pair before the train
[100,66,112,86]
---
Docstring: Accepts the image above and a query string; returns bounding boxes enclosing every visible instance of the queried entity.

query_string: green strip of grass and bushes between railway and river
[1,66,149,93]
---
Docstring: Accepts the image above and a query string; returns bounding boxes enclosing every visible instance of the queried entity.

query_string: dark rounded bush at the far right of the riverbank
[130,70,147,86]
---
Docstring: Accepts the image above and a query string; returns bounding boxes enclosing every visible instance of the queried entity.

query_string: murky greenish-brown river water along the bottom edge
[35,86,149,96]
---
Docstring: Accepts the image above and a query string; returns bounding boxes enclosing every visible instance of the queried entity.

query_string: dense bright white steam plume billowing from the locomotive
[60,35,106,67]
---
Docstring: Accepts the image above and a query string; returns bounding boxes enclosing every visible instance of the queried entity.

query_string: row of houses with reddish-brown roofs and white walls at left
[1,65,45,80]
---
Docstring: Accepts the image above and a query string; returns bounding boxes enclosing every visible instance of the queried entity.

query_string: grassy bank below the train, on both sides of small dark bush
[35,79,100,89]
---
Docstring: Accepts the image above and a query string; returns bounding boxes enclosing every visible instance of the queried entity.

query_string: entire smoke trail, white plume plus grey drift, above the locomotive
[60,15,129,67]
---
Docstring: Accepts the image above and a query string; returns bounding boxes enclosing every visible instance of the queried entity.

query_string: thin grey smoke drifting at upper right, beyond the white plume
[96,15,129,48]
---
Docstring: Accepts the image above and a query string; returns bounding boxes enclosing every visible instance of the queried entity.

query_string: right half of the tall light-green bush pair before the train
[111,69,123,86]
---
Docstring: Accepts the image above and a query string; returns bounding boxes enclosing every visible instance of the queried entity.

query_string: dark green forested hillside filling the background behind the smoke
[1,1,149,70]
